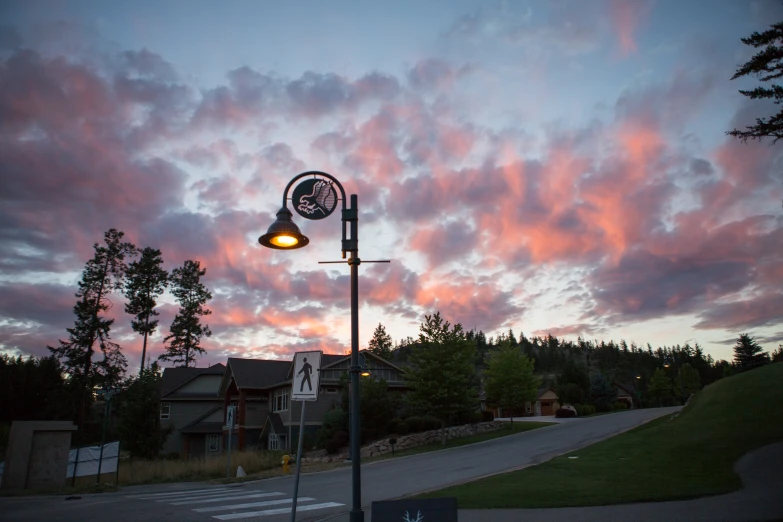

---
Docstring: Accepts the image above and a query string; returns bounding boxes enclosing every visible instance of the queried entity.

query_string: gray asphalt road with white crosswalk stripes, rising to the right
[0,408,679,522]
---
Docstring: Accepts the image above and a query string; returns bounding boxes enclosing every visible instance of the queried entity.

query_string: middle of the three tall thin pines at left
[125,247,169,371]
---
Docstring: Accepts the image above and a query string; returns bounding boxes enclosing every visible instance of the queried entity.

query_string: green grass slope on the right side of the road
[421,363,783,509]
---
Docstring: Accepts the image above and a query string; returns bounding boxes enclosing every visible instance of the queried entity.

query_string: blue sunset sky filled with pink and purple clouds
[0,0,783,371]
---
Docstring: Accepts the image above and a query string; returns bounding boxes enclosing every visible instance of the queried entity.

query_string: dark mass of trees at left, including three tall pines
[0,229,212,443]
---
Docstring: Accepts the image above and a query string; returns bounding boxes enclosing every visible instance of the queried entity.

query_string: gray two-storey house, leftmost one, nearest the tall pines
[160,364,226,457]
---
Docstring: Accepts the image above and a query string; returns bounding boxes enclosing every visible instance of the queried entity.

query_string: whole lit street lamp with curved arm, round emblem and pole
[258,171,389,522]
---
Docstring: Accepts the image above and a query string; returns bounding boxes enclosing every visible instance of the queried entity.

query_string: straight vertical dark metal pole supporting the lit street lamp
[348,194,364,522]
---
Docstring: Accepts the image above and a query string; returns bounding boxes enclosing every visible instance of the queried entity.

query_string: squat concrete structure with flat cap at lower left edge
[2,421,76,490]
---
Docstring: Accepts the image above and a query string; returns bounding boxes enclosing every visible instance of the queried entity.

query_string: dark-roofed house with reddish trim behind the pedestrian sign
[219,350,405,450]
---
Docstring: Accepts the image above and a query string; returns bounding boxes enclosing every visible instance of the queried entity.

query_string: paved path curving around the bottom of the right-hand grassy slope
[459,442,783,522]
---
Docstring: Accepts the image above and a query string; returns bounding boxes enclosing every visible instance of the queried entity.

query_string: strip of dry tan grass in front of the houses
[120,450,283,485]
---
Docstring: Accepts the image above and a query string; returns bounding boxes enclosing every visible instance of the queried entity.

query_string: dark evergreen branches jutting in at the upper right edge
[727,22,783,143]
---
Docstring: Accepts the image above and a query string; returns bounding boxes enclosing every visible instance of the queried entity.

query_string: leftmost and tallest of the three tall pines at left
[48,229,136,425]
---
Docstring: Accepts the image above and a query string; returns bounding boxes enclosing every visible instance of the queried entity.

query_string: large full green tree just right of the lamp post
[404,312,478,445]
